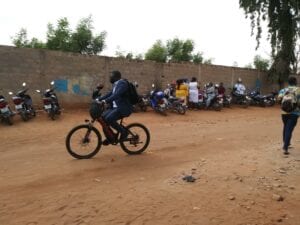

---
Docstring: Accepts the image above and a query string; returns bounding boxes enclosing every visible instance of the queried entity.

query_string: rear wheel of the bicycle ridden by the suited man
[120,123,150,155]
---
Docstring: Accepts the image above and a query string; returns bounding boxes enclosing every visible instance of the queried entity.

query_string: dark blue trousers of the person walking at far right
[282,114,298,151]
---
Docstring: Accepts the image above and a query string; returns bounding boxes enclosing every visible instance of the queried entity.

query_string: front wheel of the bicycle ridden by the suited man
[66,124,102,159]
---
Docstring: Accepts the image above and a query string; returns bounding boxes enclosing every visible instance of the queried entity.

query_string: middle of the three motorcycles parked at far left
[9,82,36,121]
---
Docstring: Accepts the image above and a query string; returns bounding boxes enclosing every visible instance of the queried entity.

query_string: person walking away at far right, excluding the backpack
[278,77,300,155]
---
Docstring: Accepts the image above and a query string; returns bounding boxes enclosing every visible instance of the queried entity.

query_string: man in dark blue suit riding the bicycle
[97,71,133,145]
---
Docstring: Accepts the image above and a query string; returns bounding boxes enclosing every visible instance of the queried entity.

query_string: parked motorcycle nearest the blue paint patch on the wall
[36,81,61,120]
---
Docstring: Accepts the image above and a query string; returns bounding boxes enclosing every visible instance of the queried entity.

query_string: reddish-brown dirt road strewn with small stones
[0,108,300,225]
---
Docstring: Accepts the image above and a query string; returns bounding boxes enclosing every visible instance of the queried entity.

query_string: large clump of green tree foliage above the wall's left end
[13,16,106,55]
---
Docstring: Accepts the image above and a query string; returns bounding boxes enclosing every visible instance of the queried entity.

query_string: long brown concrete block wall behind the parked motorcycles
[0,46,274,107]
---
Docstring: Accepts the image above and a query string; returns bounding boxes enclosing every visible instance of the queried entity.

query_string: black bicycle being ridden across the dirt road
[66,102,150,159]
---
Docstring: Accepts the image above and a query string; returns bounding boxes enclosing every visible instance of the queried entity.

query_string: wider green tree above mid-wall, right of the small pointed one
[167,38,194,62]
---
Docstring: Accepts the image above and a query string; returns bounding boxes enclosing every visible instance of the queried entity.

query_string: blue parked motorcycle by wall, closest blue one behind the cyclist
[150,84,168,116]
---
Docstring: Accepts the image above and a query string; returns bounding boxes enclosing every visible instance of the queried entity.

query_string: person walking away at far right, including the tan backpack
[278,77,300,155]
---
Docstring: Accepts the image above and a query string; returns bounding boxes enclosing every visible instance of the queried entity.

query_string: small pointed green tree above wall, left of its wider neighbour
[145,40,168,63]
